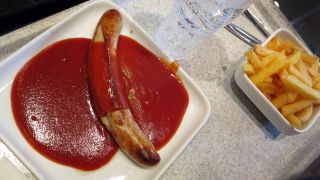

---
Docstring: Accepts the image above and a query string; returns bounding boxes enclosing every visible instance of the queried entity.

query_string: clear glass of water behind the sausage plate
[155,0,254,60]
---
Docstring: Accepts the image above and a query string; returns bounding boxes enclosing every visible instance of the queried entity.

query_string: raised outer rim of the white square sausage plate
[0,0,211,179]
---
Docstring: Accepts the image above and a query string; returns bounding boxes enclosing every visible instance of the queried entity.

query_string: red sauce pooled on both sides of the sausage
[11,36,189,171]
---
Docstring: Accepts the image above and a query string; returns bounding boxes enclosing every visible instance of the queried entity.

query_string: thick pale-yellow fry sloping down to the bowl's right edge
[282,75,320,100]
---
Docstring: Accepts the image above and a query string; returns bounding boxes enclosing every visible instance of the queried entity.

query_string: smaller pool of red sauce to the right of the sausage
[118,36,189,149]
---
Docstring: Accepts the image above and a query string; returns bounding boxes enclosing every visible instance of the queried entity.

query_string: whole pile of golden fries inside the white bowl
[243,38,320,128]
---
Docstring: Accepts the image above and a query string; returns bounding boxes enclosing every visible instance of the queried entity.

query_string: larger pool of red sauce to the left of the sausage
[11,39,118,170]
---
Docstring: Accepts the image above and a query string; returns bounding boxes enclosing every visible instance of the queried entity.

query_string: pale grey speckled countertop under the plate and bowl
[0,0,320,179]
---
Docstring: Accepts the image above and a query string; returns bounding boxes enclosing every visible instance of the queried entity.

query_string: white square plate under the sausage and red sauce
[0,0,210,180]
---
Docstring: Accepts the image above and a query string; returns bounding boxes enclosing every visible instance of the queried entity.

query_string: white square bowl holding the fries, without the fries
[235,29,320,135]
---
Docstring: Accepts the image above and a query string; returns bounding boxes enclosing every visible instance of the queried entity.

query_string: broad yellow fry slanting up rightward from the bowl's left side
[250,57,288,85]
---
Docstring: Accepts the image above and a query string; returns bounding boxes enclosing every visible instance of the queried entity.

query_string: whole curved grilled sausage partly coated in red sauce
[88,9,160,167]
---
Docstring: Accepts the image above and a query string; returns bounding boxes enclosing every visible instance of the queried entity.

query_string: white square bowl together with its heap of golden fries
[235,29,320,135]
